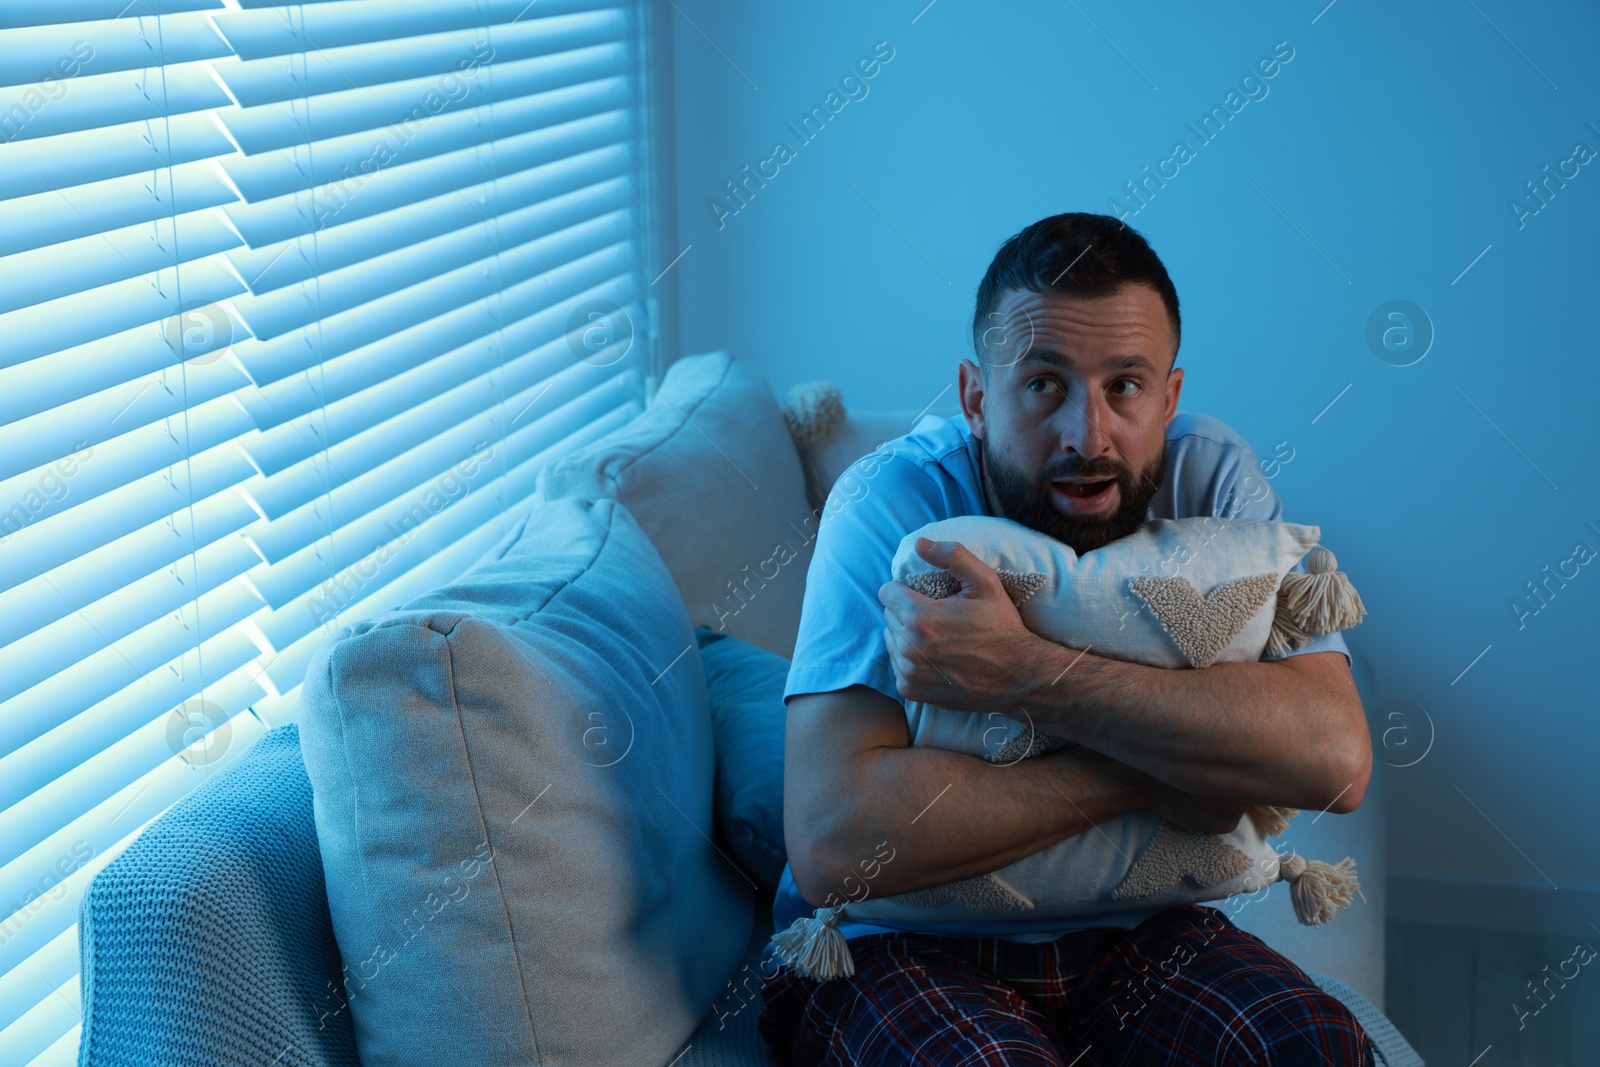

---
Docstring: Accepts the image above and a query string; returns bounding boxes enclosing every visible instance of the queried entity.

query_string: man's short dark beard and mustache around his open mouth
[978,438,1166,555]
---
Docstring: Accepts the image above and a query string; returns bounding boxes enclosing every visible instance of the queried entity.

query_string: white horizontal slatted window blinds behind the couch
[0,0,658,1064]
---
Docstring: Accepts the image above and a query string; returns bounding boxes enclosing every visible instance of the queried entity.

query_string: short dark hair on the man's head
[973,211,1182,374]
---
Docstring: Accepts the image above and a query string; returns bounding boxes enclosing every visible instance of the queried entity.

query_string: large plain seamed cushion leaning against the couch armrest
[301,499,752,1067]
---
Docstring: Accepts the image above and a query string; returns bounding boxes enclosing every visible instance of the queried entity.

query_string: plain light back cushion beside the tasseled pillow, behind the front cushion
[536,352,818,656]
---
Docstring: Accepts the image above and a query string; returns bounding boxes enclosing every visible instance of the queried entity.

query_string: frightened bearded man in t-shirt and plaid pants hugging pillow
[760,213,1373,1067]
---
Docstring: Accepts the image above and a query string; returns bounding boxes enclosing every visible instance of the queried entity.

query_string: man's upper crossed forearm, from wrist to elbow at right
[1006,638,1371,811]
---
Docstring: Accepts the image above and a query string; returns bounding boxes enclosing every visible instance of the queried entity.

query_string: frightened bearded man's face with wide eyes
[960,285,1184,555]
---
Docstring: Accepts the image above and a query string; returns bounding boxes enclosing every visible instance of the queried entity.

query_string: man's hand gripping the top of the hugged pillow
[878,537,1042,712]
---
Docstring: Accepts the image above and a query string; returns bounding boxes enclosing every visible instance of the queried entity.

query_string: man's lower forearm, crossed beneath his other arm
[802,747,1144,905]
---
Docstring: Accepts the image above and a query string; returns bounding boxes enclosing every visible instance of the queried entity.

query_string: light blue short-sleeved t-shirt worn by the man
[773,411,1350,942]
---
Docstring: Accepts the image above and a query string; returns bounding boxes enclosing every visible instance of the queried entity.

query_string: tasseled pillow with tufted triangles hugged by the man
[778,515,1365,977]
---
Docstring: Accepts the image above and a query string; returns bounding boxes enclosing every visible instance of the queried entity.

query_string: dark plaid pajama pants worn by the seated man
[760,904,1374,1067]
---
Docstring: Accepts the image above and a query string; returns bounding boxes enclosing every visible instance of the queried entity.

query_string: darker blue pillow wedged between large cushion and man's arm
[694,627,789,889]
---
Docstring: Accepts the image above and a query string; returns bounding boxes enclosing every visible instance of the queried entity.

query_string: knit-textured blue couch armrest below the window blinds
[78,725,358,1067]
